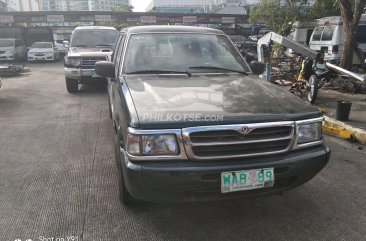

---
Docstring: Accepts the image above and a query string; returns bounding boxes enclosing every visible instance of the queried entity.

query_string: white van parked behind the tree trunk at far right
[310,14,366,64]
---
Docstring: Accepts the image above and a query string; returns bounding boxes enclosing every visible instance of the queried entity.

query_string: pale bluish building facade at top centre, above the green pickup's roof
[146,0,259,14]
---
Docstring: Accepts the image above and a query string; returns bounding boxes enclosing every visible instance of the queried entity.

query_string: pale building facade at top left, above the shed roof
[41,0,131,11]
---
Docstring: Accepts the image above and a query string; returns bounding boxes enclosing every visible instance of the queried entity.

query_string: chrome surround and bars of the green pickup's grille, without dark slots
[182,121,296,160]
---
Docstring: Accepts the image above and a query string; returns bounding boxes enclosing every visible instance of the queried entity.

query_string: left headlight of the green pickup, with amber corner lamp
[127,134,179,156]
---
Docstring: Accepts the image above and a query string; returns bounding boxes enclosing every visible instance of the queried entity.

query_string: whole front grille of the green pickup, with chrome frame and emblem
[183,122,295,159]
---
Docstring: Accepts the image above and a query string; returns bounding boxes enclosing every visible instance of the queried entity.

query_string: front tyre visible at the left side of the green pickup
[115,133,138,206]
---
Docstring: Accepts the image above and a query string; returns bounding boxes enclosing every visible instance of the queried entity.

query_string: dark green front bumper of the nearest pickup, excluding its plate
[119,146,330,202]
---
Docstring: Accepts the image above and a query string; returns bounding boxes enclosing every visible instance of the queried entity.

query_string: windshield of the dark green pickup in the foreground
[123,33,249,73]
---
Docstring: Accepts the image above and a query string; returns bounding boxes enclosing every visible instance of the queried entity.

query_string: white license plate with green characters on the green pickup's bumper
[221,168,274,193]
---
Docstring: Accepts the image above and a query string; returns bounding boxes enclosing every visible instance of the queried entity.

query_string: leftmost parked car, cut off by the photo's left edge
[0,38,27,61]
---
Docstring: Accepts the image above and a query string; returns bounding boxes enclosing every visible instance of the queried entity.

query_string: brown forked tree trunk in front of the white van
[338,0,366,69]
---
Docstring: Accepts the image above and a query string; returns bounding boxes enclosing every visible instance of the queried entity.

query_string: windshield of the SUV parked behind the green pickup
[71,29,118,48]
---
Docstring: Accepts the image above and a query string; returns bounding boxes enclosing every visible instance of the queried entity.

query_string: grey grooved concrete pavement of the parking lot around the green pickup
[0,62,366,241]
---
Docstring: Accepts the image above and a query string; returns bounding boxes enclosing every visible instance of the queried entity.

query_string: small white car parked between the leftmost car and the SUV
[28,42,60,61]
